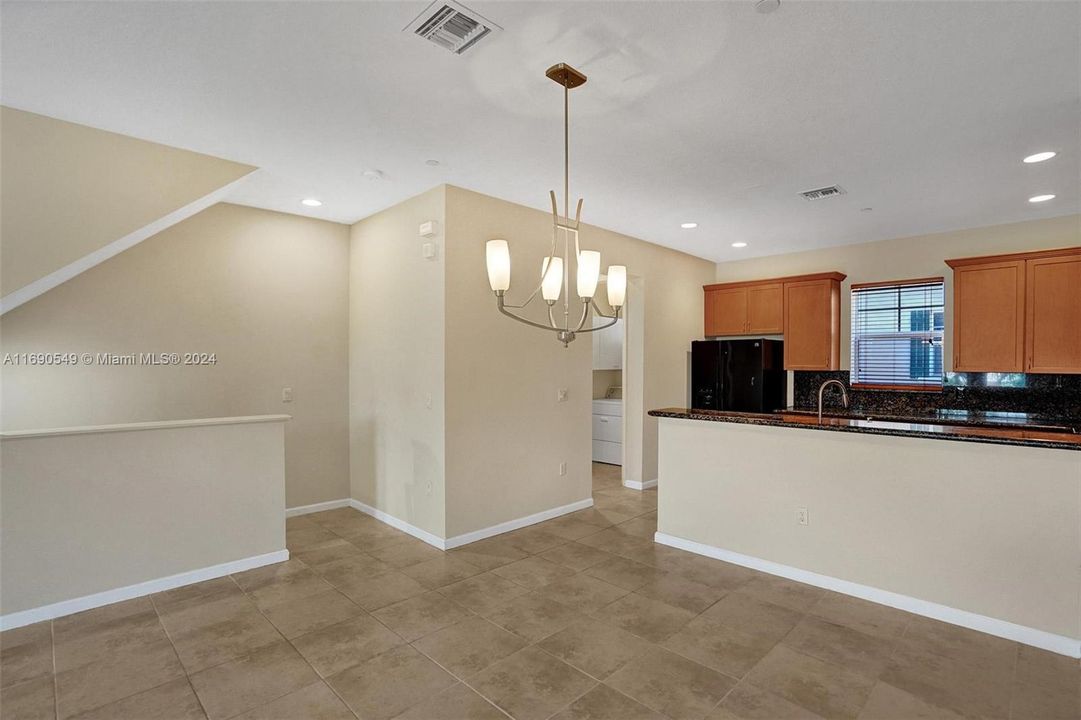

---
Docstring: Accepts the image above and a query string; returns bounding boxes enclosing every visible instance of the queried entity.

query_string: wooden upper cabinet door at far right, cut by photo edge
[1025,255,1081,373]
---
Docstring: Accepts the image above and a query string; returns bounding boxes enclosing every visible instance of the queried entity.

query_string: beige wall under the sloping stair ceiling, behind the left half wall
[0,202,349,507]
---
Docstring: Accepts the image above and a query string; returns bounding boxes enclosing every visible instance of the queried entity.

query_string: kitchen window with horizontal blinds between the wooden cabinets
[852,278,946,389]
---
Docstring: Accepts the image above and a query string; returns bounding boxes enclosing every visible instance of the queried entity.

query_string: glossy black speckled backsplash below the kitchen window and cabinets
[792,370,1081,419]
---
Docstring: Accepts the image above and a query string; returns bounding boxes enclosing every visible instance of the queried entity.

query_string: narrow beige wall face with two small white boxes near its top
[349,186,445,537]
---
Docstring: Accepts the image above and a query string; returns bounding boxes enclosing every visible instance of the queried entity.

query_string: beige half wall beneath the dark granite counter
[657,419,1081,638]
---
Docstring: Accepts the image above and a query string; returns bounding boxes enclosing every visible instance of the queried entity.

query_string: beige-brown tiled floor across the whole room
[0,465,1081,720]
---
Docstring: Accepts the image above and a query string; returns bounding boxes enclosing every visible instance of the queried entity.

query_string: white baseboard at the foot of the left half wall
[0,550,289,630]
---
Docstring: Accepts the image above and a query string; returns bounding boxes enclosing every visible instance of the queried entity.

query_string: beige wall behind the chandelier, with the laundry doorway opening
[445,187,715,536]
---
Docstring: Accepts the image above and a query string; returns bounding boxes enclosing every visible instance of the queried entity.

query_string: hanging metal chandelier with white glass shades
[485,63,627,347]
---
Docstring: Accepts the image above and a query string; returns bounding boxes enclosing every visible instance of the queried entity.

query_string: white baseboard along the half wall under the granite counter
[654,532,1081,657]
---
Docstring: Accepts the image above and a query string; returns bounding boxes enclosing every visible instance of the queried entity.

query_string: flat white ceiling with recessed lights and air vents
[0,0,1081,261]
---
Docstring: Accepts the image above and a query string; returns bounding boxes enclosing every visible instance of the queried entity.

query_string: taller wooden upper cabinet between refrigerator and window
[785,280,841,370]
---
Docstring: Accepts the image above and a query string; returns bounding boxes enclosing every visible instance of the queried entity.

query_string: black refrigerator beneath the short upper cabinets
[691,339,787,413]
